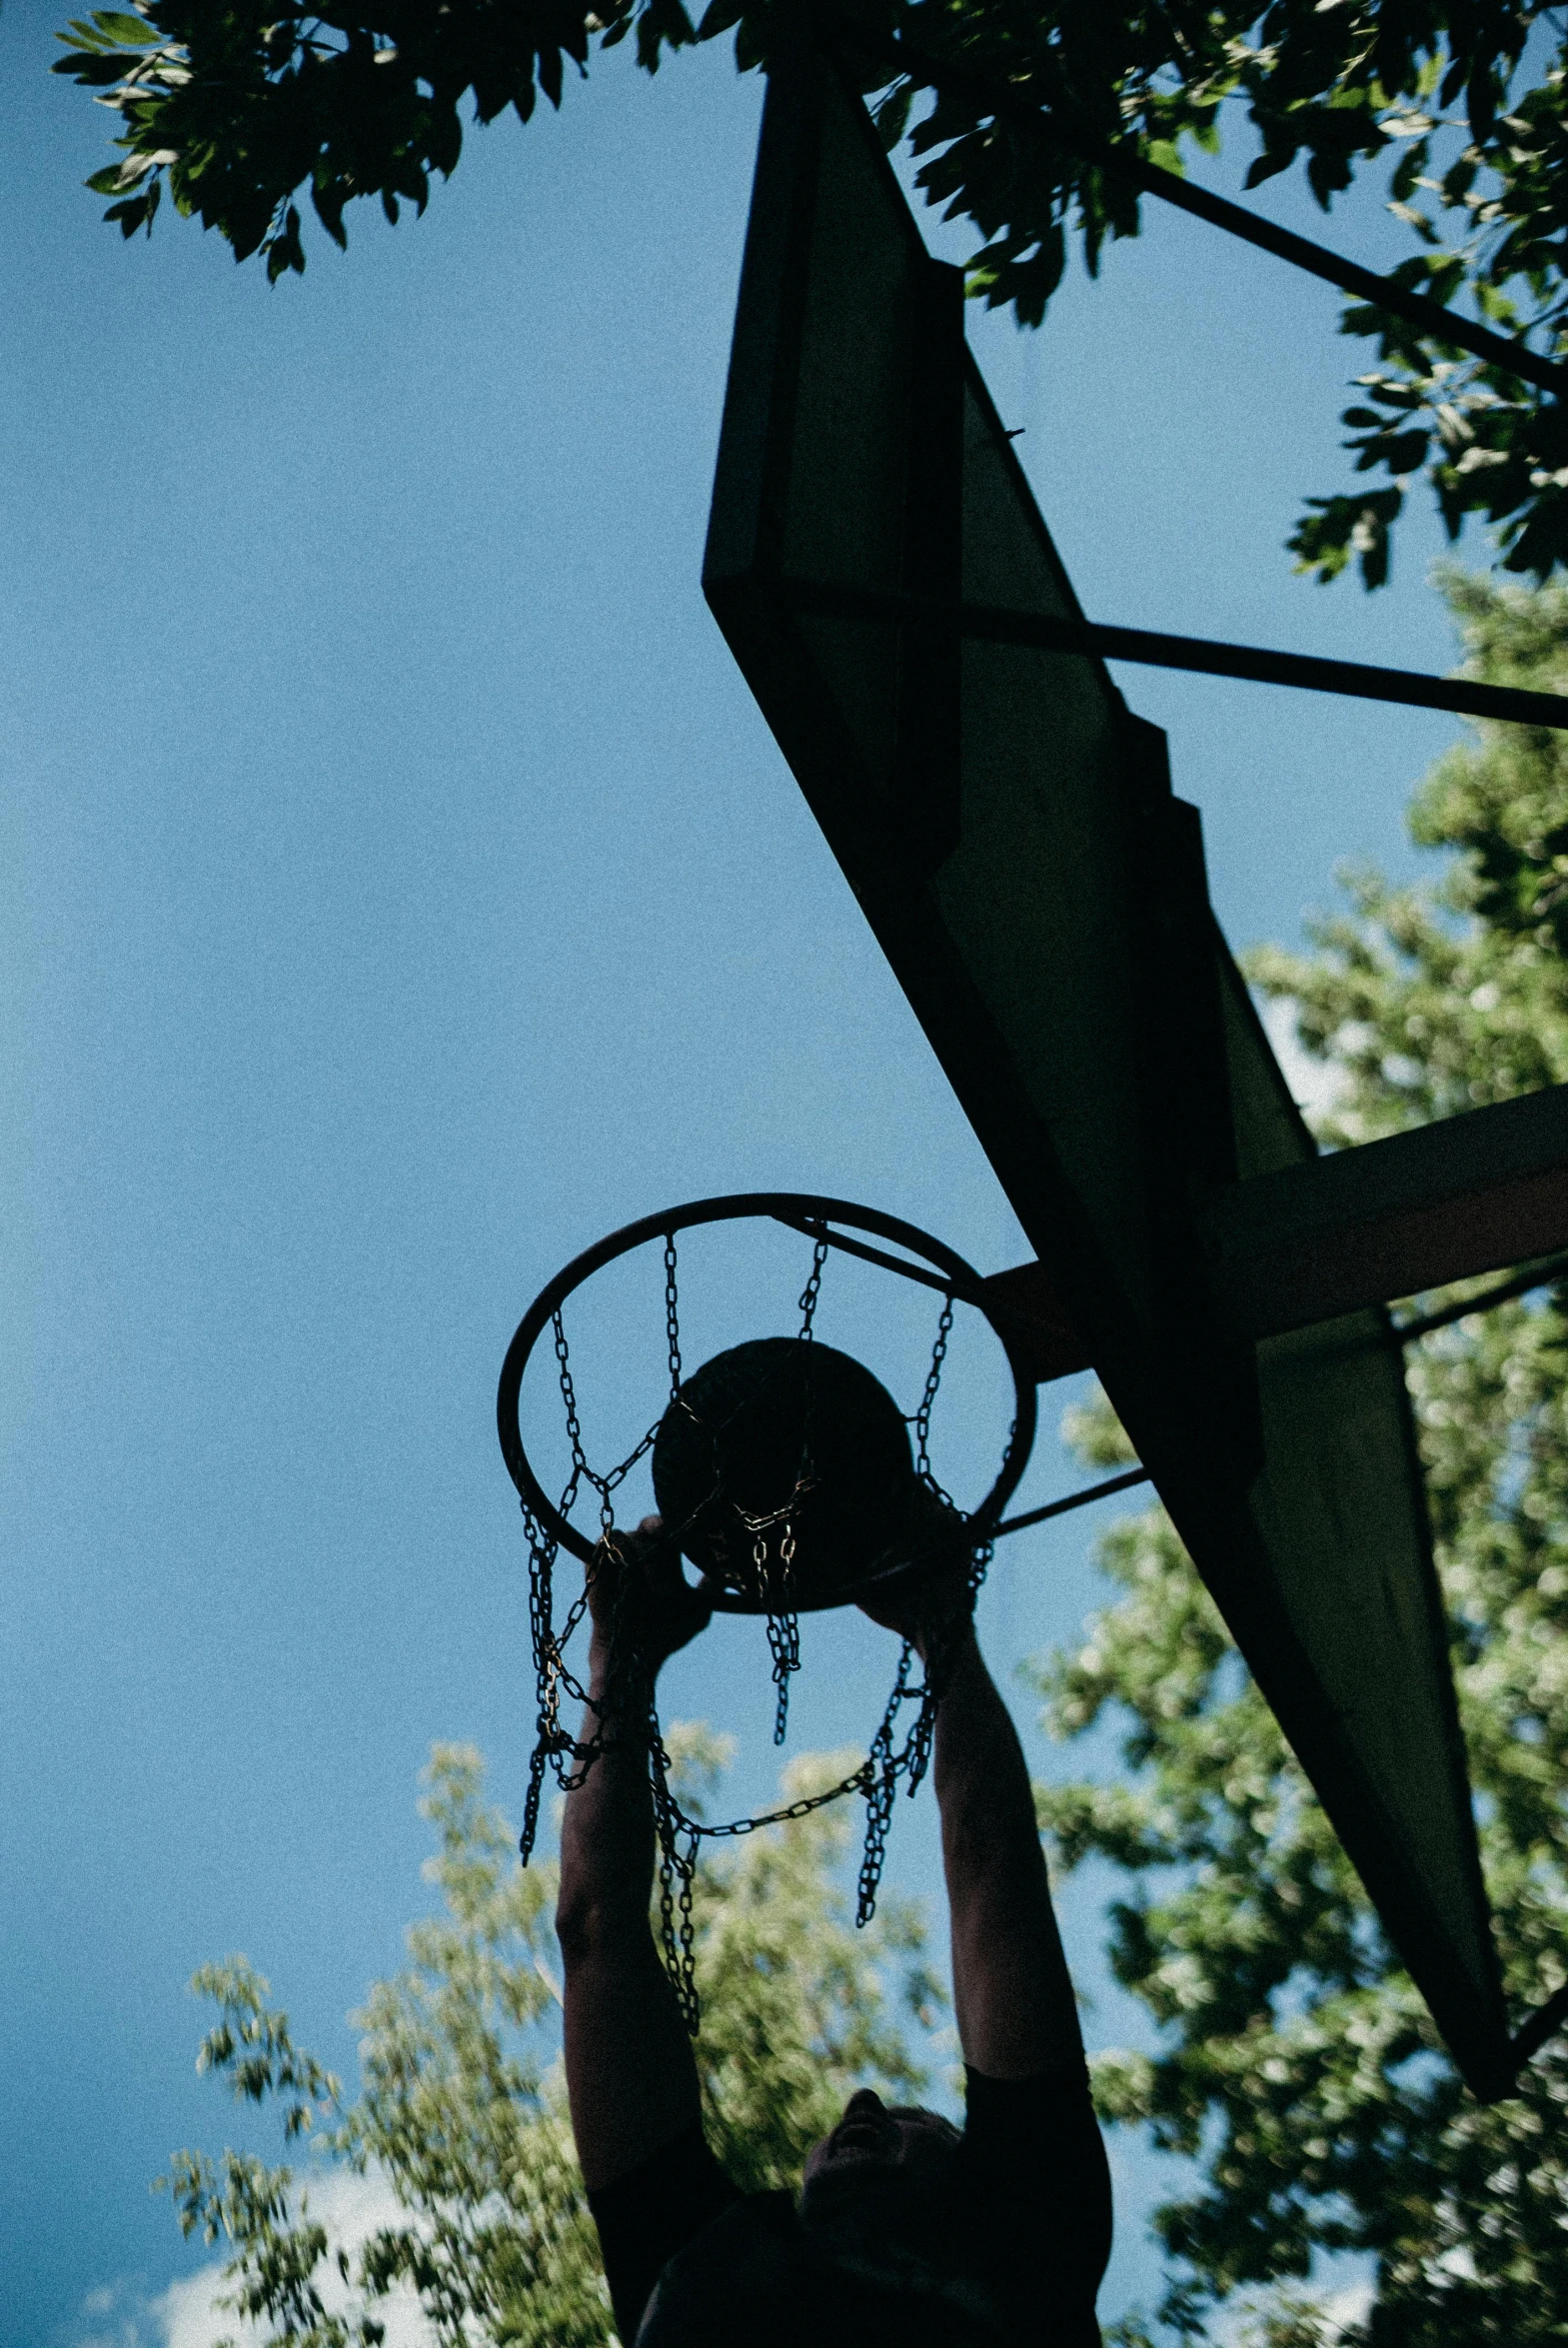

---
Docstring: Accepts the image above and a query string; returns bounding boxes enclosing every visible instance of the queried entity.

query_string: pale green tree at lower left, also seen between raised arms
[160,1726,941,2348]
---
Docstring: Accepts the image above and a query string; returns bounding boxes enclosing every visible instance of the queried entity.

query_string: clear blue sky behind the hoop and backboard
[0,0,1455,2348]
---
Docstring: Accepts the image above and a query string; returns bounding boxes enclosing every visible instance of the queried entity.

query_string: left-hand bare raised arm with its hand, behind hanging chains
[557,1526,709,2193]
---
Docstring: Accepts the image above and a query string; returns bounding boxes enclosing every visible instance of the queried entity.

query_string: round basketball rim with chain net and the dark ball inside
[496,1190,1035,2031]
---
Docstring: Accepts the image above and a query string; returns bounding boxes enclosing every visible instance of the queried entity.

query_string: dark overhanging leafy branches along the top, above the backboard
[42,0,1568,587]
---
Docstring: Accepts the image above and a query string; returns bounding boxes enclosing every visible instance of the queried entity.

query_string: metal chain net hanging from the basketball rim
[519,1232,990,2036]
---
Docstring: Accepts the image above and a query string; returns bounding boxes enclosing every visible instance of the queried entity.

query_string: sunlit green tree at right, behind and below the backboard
[1040,559,1568,2348]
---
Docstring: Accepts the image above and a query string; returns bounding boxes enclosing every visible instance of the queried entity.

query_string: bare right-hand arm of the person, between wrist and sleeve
[934,1629,1082,2078]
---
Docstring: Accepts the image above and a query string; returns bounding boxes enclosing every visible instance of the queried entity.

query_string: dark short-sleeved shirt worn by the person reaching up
[590,2064,1110,2348]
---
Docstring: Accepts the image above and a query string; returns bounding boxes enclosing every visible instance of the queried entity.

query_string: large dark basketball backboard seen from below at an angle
[705,32,1507,2094]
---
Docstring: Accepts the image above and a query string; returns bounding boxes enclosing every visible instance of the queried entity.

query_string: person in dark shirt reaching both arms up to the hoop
[557,1516,1110,2348]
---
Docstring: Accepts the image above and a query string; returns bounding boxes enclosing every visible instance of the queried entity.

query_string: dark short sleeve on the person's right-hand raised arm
[964,2064,1110,2348]
